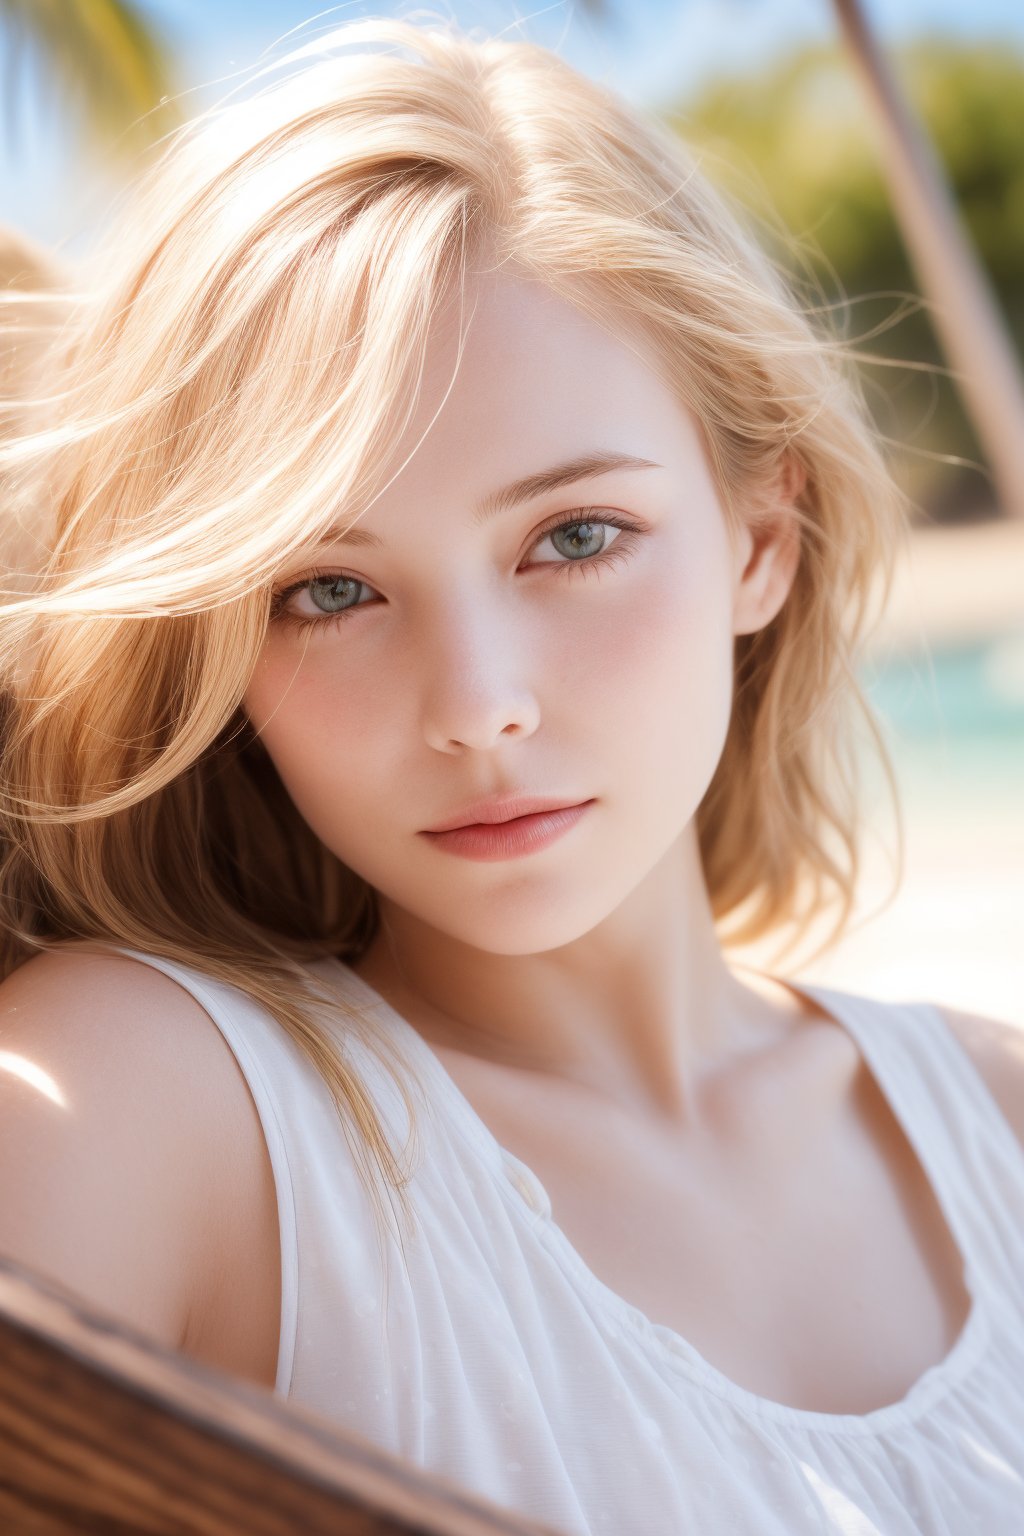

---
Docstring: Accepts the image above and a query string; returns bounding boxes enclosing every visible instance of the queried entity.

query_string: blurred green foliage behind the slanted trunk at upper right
[666,38,1024,519]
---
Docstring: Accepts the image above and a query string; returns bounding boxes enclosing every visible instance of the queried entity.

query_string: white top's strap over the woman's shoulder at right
[786,982,1024,1326]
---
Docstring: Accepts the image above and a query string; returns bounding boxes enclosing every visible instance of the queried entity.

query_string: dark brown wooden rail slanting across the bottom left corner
[0,1256,564,1536]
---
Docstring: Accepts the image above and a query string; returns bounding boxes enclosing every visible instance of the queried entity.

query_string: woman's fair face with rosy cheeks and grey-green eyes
[244,273,795,954]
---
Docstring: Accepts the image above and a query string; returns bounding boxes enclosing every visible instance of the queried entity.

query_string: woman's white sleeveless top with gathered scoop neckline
[110,949,1024,1536]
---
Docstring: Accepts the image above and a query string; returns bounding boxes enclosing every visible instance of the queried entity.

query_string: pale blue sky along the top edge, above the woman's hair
[0,0,1024,255]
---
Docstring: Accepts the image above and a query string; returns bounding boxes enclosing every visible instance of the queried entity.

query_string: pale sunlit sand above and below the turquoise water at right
[734,519,1024,1029]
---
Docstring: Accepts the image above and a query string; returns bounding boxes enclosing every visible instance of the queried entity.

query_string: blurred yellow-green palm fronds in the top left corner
[0,0,181,160]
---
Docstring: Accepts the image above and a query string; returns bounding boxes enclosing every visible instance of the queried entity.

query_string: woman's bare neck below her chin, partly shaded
[352,836,809,1123]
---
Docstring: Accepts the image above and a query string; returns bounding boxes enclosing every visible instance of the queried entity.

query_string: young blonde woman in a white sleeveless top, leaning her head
[0,22,1024,1536]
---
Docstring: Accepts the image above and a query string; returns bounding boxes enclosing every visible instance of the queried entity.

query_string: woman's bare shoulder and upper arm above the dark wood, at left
[0,949,276,1373]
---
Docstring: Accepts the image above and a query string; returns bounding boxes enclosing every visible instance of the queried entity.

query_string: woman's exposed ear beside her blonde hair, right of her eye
[732,453,808,634]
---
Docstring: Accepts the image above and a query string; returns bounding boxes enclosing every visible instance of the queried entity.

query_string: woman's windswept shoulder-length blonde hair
[0,9,906,1234]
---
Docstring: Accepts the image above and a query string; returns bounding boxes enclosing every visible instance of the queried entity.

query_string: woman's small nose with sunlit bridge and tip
[416,588,540,754]
